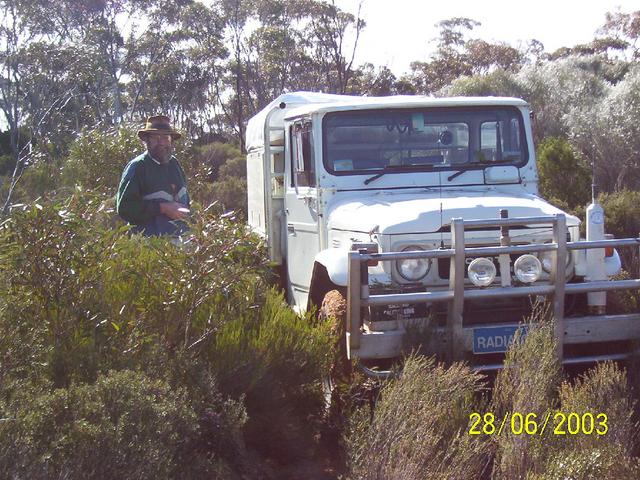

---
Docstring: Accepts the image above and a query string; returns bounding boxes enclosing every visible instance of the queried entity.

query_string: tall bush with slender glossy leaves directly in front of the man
[0,196,266,386]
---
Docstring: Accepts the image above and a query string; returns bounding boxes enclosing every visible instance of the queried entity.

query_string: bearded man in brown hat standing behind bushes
[116,115,190,236]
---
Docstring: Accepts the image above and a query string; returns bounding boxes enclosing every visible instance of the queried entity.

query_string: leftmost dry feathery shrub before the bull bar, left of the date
[347,356,489,480]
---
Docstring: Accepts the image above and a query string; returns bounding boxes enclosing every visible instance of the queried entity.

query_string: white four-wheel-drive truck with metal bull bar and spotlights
[246,92,640,369]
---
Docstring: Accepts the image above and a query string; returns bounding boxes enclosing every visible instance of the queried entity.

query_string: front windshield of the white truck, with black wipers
[323,107,528,175]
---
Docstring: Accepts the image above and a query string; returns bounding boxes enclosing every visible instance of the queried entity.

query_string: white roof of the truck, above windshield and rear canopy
[246,92,528,150]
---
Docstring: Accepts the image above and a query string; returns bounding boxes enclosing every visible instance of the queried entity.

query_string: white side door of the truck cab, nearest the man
[285,120,320,308]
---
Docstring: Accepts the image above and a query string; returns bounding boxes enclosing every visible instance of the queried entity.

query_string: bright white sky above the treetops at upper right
[335,0,640,76]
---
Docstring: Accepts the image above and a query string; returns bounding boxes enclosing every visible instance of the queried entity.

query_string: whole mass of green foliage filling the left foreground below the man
[0,192,336,478]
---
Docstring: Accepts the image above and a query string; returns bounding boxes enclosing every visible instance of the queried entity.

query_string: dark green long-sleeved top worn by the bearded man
[116,152,190,235]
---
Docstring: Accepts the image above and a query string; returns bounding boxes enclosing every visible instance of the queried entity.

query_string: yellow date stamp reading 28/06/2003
[469,412,609,436]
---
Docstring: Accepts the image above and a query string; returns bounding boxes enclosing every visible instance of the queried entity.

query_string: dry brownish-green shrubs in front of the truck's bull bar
[345,308,640,480]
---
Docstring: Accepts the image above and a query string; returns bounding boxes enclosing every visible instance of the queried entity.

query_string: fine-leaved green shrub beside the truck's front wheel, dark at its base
[210,290,332,461]
